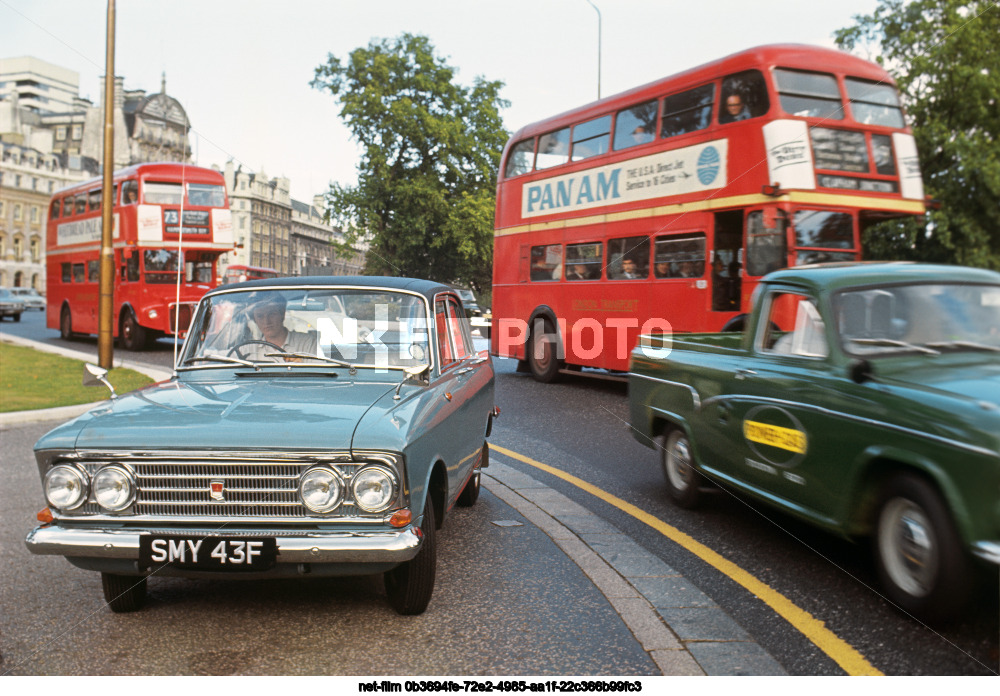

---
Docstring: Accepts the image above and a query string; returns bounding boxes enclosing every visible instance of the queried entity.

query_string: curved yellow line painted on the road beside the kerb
[490,443,883,676]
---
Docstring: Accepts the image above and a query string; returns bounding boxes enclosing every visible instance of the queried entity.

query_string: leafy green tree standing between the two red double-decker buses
[312,34,509,291]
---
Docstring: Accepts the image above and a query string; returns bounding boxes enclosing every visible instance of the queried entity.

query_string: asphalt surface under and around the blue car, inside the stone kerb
[0,424,659,676]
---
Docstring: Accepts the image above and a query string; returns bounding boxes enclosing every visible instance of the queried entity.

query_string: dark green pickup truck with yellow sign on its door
[629,263,1000,621]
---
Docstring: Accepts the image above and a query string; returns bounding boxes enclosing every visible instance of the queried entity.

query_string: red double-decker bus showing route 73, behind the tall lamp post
[46,162,235,350]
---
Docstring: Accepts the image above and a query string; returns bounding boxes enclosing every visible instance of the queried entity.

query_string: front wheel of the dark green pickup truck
[874,474,974,622]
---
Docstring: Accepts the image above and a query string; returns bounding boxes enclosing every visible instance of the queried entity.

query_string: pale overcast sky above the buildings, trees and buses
[0,0,877,201]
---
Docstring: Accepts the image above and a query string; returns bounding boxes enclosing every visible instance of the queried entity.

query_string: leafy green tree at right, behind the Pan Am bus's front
[836,0,1000,268]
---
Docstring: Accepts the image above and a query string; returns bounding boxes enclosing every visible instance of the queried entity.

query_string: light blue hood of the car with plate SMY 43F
[53,376,395,451]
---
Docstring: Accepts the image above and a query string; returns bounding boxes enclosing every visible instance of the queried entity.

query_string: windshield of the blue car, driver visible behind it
[180,288,431,369]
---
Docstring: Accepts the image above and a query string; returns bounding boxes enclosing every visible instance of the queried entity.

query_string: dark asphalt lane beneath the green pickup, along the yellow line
[494,360,1000,674]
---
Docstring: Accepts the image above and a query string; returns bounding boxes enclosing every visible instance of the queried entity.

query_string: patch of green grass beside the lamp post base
[0,342,153,413]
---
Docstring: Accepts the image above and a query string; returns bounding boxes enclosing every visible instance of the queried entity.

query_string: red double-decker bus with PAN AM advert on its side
[491,45,925,382]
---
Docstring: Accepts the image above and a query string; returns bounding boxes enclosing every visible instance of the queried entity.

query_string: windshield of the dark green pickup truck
[833,283,1000,356]
